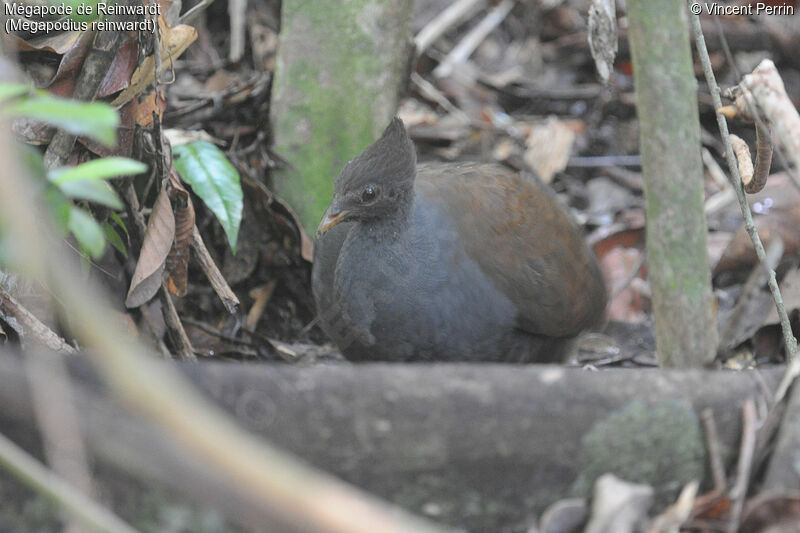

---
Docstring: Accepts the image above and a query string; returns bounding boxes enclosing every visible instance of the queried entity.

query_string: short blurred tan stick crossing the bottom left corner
[0,428,136,533]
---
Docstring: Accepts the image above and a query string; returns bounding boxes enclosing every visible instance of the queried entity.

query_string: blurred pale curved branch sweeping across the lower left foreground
[0,124,456,533]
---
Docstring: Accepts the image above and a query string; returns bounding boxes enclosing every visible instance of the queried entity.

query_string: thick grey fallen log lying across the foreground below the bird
[0,358,782,531]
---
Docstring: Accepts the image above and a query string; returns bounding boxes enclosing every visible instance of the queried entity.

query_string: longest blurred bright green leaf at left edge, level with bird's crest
[2,97,119,146]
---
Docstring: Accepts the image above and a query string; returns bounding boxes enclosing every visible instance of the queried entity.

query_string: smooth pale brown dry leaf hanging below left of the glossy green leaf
[125,189,175,308]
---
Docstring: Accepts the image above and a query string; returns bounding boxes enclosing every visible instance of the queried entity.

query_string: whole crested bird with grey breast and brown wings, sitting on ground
[312,118,606,362]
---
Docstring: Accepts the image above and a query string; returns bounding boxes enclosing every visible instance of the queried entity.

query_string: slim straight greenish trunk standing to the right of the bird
[627,0,718,367]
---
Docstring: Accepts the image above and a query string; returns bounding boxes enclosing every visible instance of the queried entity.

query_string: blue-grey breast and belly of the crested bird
[335,195,515,358]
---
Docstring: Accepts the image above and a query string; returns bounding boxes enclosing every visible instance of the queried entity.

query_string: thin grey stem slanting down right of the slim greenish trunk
[689,5,800,382]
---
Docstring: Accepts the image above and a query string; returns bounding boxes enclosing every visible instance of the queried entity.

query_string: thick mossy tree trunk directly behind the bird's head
[271,0,412,236]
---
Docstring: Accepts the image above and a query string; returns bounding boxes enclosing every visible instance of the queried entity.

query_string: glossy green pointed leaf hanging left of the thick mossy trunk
[173,141,242,253]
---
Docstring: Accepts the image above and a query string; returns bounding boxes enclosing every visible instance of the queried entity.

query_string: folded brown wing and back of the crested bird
[416,164,605,337]
